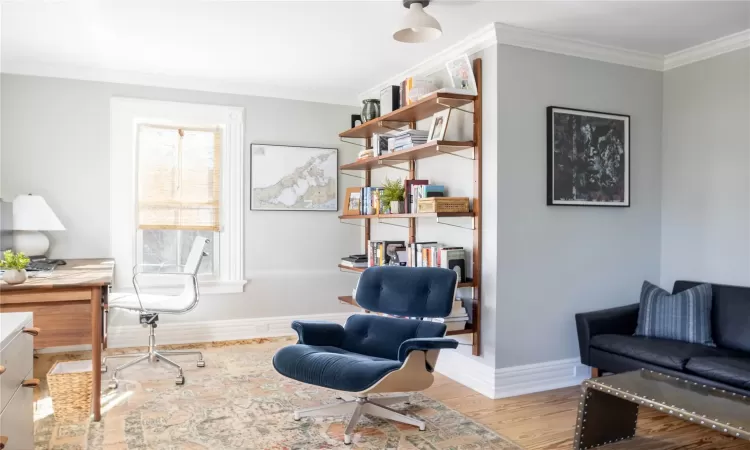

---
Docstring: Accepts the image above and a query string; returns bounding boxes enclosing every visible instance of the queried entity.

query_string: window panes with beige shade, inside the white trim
[136,124,221,278]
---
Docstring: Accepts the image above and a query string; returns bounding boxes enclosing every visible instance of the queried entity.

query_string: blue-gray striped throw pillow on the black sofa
[635,281,715,347]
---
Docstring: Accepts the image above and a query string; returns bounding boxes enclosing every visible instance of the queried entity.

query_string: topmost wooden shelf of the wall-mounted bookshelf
[339,92,476,139]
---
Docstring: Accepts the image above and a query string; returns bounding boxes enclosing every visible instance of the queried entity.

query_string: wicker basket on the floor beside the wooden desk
[47,360,93,422]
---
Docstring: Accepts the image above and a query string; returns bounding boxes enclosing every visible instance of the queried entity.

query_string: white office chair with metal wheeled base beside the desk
[102,237,209,389]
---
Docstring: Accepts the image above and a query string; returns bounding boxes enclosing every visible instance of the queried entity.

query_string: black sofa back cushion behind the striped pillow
[672,280,750,353]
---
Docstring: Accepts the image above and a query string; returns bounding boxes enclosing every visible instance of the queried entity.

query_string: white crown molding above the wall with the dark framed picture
[494,23,664,71]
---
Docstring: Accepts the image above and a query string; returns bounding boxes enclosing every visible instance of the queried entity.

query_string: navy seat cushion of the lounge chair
[273,344,402,392]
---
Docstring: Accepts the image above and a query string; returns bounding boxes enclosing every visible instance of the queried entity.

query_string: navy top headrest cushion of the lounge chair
[356,266,458,317]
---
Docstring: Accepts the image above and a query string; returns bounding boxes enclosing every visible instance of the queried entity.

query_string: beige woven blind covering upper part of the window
[137,124,221,231]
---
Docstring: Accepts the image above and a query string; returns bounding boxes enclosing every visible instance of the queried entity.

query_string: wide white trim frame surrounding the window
[110,97,247,293]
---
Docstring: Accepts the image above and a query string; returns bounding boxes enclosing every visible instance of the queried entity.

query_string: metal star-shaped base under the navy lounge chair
[294,395,426,445]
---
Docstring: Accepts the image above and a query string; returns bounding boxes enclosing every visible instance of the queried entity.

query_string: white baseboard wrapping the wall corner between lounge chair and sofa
[436,350,591,399]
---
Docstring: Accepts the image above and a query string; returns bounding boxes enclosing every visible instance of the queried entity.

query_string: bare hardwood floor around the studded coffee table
[425,375,750,450]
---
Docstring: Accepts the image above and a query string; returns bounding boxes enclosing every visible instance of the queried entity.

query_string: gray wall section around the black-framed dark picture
[500,45,662,367]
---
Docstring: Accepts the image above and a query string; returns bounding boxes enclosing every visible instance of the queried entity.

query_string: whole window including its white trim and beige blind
[109,98,246,293]
